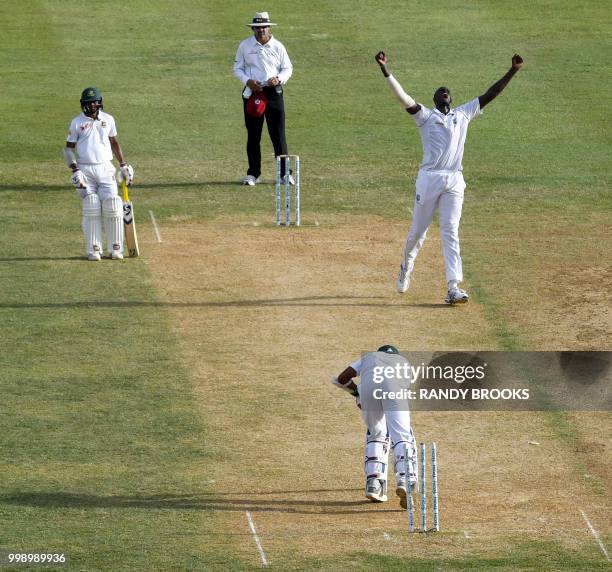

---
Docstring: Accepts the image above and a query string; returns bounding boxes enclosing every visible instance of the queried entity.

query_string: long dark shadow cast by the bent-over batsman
[0,489,394,515]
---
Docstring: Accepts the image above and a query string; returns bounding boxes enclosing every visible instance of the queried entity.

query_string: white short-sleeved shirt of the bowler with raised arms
[412,98,482,171]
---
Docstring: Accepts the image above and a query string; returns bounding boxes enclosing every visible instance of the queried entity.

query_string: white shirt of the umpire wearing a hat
[234,36,293,98]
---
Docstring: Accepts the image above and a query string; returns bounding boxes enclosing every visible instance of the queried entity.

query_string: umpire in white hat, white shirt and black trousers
[234,12,293,186]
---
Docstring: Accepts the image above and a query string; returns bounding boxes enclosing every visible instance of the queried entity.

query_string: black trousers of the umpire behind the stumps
[242,87,287,177]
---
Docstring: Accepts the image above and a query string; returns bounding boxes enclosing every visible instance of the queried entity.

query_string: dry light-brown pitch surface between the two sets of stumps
[149,217,612,566]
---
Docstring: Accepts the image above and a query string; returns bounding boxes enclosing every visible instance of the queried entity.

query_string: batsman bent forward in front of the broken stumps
[332,345,417,508]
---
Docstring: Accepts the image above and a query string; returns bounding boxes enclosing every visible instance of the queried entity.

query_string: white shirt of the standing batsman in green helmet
[66,111,117,164]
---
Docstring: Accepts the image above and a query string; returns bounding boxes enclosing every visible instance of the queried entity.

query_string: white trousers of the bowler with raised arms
[402,170,465,282]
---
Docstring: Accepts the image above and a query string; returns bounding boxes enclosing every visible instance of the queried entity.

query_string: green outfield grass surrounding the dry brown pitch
[0,0,612,570]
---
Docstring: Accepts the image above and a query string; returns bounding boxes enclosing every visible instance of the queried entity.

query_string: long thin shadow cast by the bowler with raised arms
[0,295,448,309]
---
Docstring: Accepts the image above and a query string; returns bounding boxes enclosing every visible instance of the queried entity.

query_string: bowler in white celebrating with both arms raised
[375,52,523,304]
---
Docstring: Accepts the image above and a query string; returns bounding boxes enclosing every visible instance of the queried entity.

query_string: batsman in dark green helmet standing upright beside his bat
[64,87,134,261]
